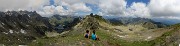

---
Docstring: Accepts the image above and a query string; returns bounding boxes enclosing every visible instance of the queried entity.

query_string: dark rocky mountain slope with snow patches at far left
[0,11,52,44]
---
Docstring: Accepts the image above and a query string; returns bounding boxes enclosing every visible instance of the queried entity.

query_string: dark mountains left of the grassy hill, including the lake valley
[0,11,81,44]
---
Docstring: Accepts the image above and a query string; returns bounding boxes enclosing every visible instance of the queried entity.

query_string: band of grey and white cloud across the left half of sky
[0,0,91,16]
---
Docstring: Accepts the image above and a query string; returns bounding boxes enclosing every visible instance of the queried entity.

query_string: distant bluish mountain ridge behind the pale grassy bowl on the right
[108,17,167,29]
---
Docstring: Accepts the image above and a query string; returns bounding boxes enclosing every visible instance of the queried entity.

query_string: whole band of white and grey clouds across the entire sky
[0,0,180,19]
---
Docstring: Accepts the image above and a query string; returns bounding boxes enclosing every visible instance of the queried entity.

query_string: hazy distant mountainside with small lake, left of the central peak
[48,15,81,33]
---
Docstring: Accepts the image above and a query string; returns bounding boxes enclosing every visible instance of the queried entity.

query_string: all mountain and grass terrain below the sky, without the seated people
[0,11,180,46]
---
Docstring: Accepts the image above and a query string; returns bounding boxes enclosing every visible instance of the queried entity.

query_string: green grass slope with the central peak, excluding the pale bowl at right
[28,17,180,46]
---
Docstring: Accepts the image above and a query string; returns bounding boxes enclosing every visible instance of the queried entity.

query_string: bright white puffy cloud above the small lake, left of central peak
[39,0,92,16]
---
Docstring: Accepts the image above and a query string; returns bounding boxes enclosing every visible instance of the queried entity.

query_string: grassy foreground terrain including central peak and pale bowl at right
[26,15,179,46]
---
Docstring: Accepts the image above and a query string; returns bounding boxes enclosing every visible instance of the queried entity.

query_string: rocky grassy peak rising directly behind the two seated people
[75,13,106,30]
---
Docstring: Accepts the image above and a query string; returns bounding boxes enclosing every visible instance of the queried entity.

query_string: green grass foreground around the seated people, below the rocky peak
[29,17,180,46]
